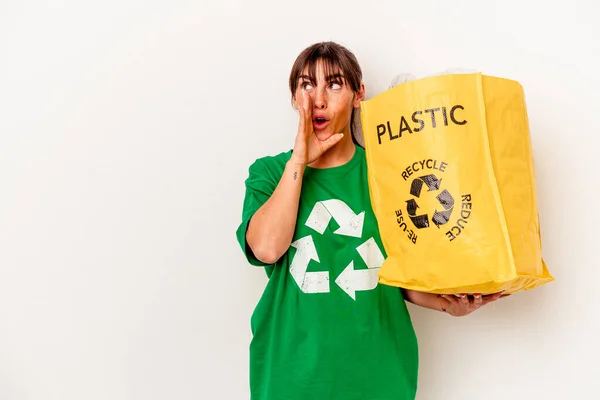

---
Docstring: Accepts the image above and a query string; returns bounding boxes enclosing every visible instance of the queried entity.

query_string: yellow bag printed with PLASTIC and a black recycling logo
[361,73,554,294]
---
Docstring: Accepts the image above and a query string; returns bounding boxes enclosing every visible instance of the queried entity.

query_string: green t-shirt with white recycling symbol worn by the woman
[237,147,418,400]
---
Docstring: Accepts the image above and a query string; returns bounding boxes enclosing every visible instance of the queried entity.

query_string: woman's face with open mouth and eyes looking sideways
[294,62,365,144]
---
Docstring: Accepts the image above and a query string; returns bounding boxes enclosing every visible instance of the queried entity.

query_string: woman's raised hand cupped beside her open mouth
[292,90,344,166]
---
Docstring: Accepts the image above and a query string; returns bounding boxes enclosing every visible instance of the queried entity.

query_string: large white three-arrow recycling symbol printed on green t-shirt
[290,199,384,300]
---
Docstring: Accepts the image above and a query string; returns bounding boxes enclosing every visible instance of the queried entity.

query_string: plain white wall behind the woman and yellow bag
[0,0,600,400]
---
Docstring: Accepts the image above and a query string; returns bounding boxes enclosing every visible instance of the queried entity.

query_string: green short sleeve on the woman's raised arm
[236,159,281,266]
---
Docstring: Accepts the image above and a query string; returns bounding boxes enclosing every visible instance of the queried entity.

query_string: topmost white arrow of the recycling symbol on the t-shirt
[306,199,365,238]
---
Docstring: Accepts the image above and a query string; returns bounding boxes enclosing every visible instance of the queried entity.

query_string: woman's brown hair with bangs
[289,42,362,145]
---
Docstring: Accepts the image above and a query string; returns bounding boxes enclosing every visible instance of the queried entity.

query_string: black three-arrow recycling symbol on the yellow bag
[406,174,454,229]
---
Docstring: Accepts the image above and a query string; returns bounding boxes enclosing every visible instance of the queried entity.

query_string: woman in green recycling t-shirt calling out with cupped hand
[237,42,500,400]
